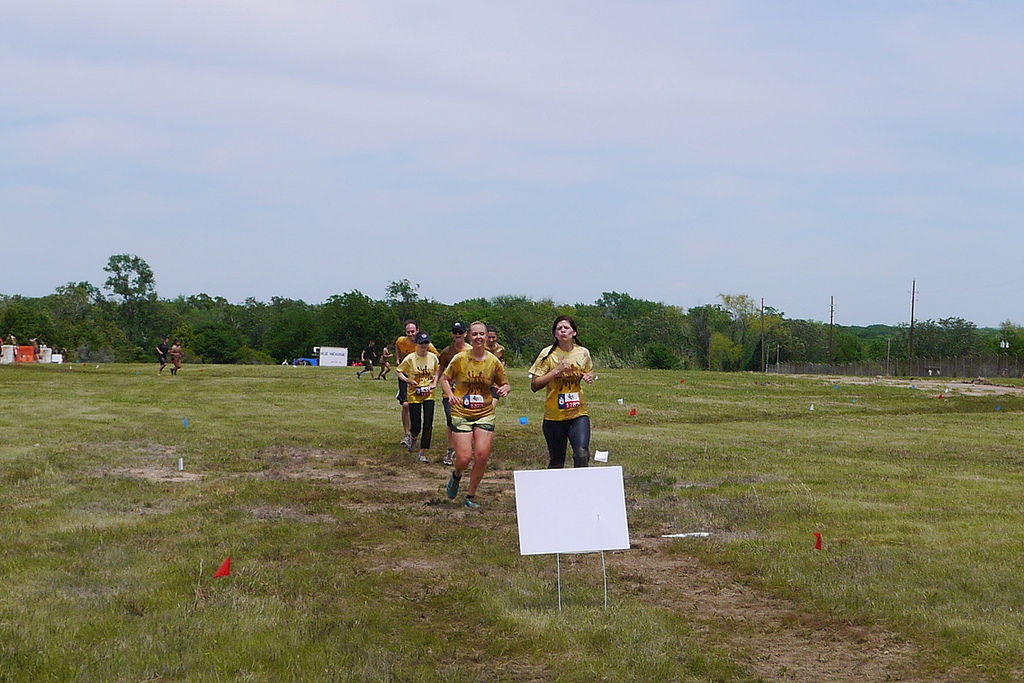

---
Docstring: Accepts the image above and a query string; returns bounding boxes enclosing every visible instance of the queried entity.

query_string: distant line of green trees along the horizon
[0,254,1024,371]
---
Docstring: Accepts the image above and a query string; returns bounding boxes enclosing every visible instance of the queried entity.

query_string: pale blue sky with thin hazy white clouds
[0,0,1024,327]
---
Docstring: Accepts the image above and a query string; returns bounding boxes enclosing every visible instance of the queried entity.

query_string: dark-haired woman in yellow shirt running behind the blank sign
[529,315,594,469]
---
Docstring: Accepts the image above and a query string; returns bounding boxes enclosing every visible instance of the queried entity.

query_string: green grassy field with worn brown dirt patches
[0,365,1024,682]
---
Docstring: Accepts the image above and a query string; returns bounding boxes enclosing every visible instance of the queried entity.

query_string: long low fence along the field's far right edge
[767,355,1024,379]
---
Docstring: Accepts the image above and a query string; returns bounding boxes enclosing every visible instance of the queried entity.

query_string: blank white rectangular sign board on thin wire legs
[515,467,630,555]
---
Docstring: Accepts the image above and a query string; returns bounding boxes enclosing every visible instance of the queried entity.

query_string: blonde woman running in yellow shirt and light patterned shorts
[441,321,512,508]
